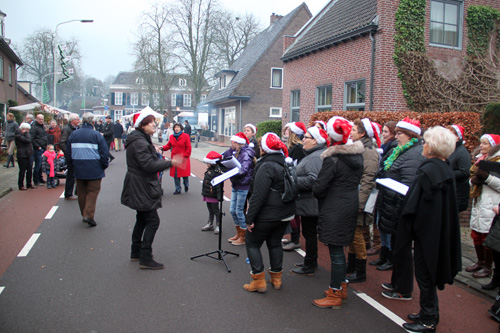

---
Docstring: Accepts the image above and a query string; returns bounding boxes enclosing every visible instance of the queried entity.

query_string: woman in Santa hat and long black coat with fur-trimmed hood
[312,117,365,309]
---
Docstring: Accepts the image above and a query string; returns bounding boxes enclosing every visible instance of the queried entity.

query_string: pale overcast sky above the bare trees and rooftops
[0,0,329,80]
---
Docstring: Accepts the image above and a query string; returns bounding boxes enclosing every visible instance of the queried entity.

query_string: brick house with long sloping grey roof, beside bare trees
[207,3,312,141]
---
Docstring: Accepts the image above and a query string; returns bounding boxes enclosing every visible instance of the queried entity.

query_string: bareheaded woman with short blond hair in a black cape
[394,126,462,332]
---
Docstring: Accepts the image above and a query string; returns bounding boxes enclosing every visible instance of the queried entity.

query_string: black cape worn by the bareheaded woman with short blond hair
[394,158,462,290]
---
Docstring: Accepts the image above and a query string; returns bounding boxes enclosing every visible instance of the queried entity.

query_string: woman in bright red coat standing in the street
[162,124,191,195]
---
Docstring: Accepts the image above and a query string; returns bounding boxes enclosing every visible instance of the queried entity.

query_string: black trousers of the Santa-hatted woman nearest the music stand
[245,221,289,274]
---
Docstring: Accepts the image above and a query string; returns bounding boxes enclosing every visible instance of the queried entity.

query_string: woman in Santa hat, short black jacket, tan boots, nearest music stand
[243,133,295,293]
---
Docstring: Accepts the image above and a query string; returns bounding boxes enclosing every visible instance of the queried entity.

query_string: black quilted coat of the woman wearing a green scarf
[377,141,425,235]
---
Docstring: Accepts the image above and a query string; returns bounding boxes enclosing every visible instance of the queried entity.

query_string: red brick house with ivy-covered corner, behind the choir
[281,0,500,123]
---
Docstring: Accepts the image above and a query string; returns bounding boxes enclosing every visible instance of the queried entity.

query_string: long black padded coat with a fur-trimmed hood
[313,141,365,246]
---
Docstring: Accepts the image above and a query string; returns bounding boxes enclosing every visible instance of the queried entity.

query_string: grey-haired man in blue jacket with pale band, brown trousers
[66,112,109,227]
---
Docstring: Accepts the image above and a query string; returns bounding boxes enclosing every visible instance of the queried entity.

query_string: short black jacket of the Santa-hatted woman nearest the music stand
[246,154,295,224]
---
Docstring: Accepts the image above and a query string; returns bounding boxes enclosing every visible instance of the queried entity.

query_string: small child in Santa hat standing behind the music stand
[201,151,223,234]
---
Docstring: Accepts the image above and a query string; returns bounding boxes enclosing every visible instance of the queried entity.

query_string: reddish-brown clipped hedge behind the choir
[309,111,484,152]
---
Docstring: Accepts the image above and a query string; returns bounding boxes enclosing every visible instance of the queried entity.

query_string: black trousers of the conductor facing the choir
[130,210,160,263]
